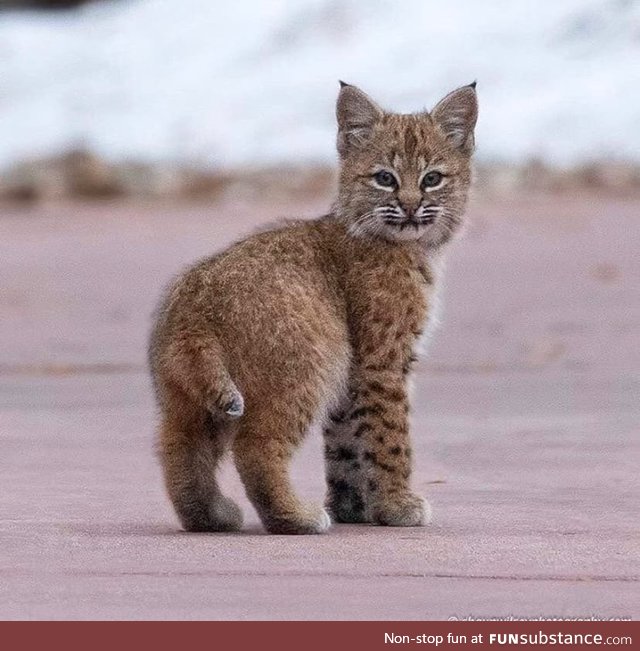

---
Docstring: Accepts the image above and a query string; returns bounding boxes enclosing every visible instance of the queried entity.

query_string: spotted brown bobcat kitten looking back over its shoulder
[149,82,477,534]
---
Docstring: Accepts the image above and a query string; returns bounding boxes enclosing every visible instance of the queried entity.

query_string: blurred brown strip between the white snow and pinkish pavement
[0,150,640,202]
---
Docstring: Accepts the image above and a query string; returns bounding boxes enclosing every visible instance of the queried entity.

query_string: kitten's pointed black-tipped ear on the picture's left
[336,81,383,156]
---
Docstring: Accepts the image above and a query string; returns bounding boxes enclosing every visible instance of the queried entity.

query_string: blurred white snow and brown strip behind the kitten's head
[0,0,640,200]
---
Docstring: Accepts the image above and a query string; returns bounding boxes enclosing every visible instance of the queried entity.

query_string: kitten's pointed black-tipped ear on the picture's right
[431,81,478,155]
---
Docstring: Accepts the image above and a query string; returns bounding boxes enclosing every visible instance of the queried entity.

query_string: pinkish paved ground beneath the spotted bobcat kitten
[0,191,640,619]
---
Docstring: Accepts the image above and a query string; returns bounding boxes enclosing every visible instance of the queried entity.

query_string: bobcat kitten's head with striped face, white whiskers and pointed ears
[336,82,478,248]
